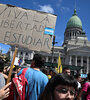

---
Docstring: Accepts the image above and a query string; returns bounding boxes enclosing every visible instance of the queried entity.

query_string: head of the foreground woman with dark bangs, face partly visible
[38,73,77,100]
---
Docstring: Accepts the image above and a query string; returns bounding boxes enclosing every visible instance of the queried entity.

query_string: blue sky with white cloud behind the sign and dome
[0,0,90,53]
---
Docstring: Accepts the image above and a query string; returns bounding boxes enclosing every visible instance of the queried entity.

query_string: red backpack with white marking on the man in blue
[8,68,29,100]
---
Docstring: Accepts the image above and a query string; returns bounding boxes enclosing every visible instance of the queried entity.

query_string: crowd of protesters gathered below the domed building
[0,54,90,100]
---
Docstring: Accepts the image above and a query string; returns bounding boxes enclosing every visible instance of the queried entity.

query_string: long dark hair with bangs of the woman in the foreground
[38,73,77,100]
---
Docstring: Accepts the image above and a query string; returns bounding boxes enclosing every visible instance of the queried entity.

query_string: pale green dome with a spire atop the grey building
[67,9,82,29]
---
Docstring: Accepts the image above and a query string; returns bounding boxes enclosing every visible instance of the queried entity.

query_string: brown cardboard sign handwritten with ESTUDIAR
[0,4,57,52]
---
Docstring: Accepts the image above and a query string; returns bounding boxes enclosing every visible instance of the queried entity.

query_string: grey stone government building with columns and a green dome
[10,9,90,74]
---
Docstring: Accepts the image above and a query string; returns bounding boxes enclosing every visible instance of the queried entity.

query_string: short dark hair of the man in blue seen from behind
[33,54,45,68]
